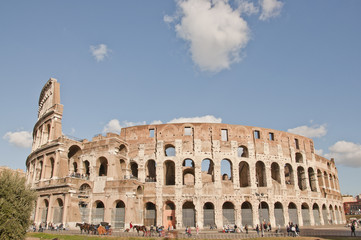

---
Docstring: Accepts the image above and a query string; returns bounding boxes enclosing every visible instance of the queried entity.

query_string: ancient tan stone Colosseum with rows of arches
[26,79,345,229]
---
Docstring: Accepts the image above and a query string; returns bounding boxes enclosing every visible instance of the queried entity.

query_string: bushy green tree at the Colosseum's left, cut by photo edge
[0,170,36,239]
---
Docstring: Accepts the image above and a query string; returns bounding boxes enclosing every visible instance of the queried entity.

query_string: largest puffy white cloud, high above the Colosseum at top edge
[169,0,251,72]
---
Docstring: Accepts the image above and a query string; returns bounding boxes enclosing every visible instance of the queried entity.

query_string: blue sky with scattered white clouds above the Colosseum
[0,0,361,195]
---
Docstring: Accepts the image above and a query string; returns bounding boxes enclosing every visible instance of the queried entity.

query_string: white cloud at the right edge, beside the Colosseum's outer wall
[325,141,361,167]
